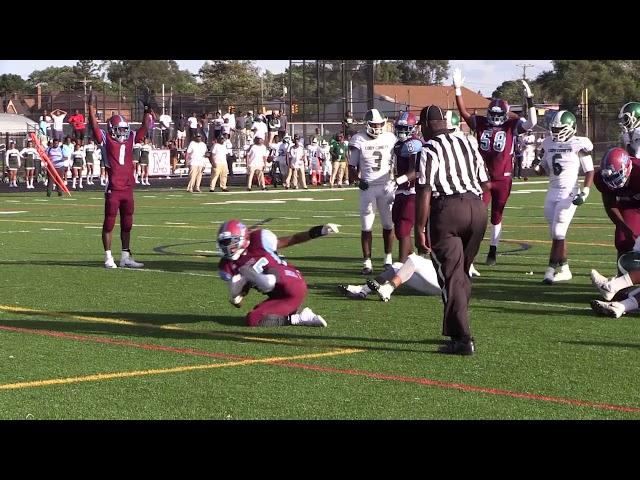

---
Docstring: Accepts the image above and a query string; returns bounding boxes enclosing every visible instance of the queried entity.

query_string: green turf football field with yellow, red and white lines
[0,182,640,420]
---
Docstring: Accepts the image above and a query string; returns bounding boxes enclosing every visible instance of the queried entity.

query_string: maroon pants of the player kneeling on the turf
[247,268,307,327]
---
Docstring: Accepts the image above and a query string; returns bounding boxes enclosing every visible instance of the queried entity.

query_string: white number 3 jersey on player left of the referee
[349,132,396,185]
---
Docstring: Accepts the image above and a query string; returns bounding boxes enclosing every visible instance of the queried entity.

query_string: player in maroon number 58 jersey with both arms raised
[453,68,538,265]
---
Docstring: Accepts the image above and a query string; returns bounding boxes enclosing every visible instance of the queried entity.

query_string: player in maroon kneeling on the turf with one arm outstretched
[218,220,339,327]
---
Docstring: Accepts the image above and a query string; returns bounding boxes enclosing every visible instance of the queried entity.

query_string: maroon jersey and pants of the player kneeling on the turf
[218,229,307,327]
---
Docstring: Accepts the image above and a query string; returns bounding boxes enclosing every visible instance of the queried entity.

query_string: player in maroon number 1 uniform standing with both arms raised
[88,95,152,268]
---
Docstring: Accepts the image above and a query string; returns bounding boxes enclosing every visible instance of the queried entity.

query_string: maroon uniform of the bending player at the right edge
[593,157,640,255]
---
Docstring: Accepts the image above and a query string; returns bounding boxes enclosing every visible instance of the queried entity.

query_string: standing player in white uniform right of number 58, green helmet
[536,110,594,284]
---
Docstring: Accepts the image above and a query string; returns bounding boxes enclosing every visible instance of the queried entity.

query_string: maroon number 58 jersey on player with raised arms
[475,116,520,180]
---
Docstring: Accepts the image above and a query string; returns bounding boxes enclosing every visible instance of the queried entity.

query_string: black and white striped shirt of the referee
[416,132,489,197]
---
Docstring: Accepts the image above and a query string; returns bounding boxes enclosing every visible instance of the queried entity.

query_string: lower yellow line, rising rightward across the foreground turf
[0,348,364,390]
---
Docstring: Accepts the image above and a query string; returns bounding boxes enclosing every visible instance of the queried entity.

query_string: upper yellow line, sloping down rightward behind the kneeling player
[0,305,298,345]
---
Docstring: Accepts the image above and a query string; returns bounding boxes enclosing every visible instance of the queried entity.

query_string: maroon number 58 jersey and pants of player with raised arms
[474,116,520,225]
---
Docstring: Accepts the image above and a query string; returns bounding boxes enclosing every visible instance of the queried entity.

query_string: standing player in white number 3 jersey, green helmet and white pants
[349,108,396,275]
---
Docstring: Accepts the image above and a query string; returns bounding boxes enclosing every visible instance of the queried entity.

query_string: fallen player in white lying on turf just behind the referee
[338,253,442,302]
